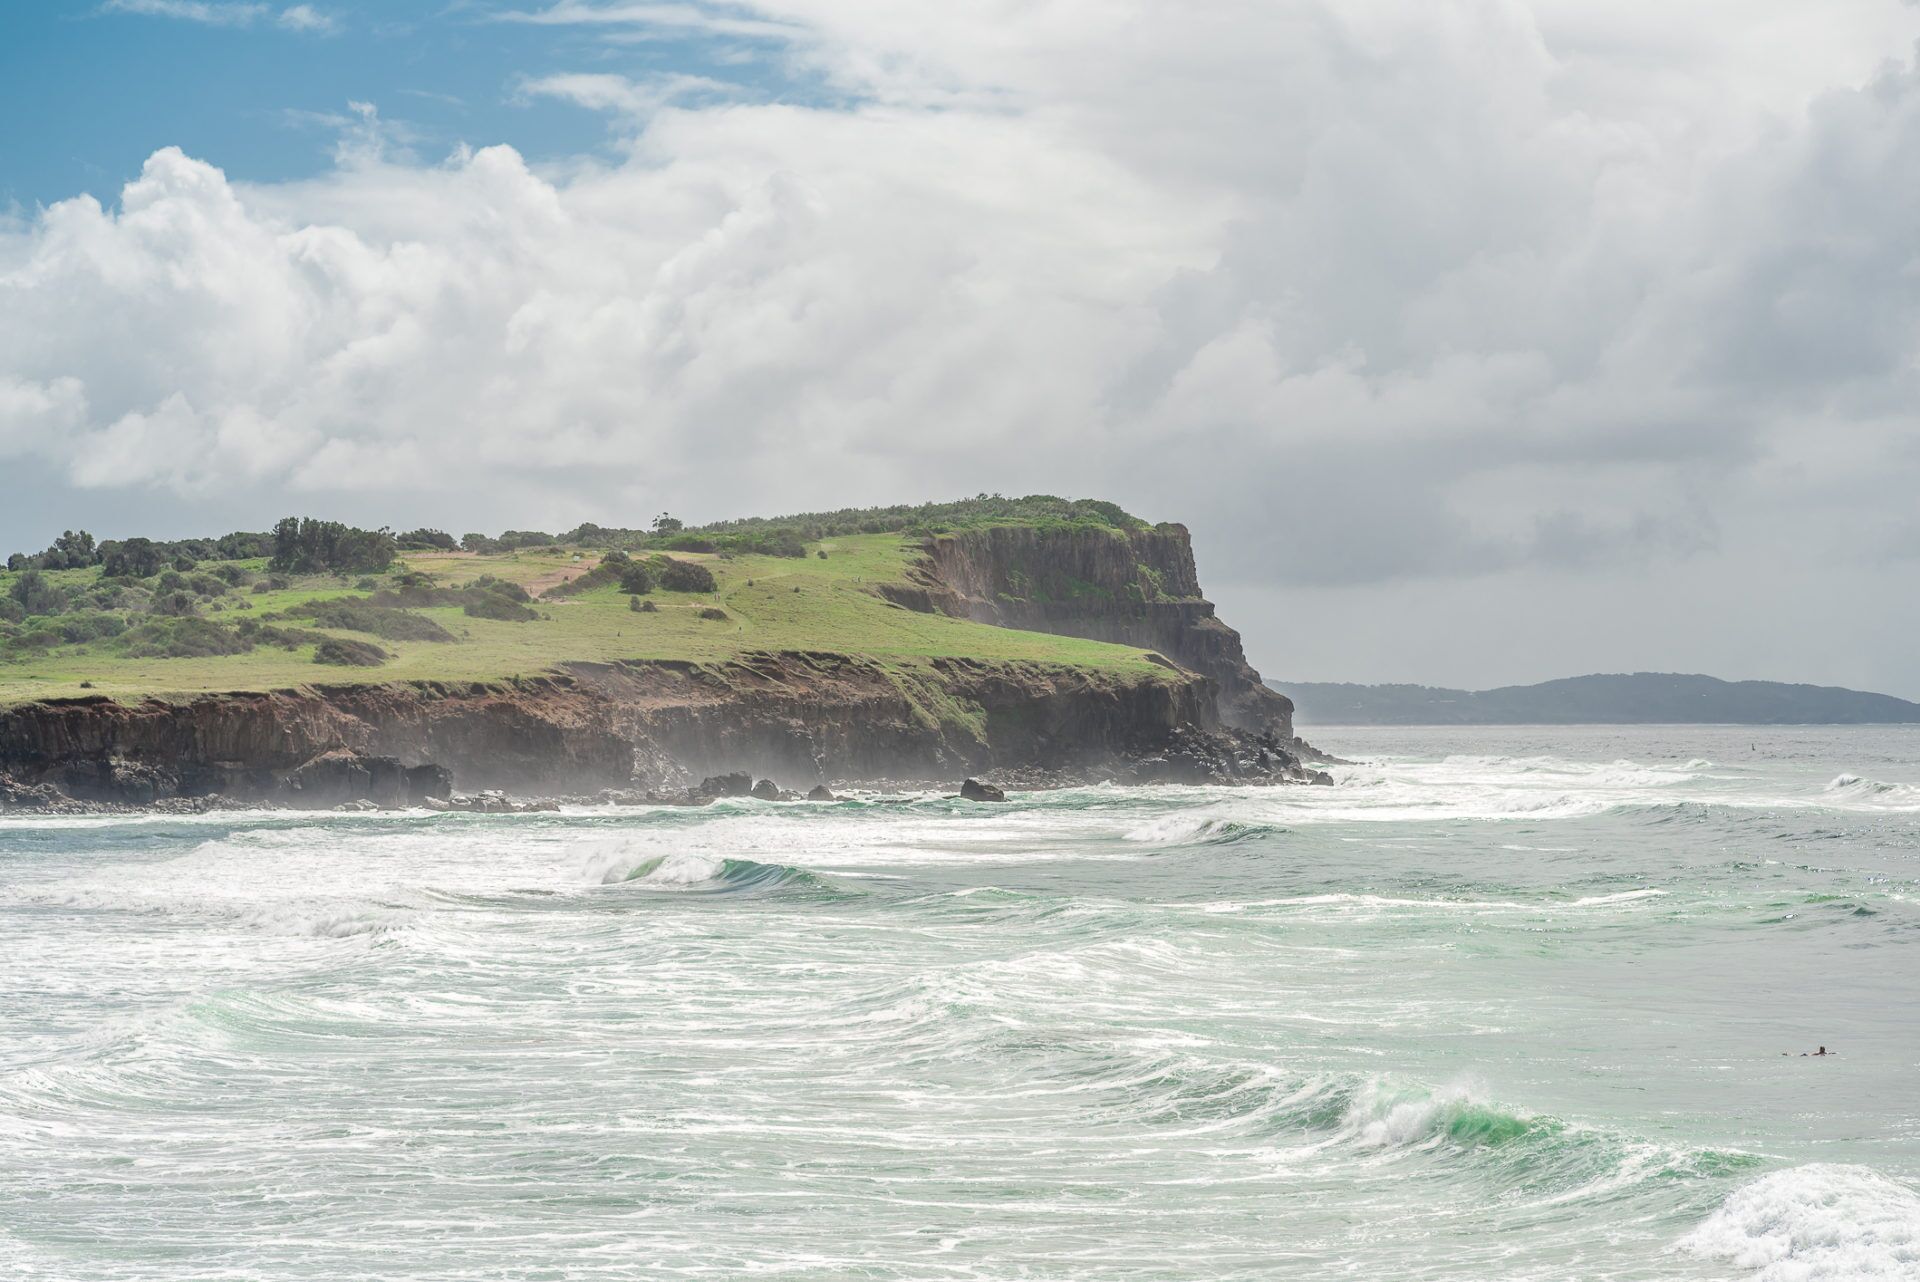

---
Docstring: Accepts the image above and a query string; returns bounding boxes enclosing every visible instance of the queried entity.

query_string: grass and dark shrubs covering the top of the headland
[0,514,1167,704]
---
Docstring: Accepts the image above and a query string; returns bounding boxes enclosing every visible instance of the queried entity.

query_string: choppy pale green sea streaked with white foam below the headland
[0,727,1920,1282]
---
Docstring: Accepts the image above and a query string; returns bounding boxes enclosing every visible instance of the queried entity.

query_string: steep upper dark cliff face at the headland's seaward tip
[883,524,1294,739]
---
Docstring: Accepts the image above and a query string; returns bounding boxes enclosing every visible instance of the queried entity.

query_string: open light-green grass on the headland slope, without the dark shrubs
[0,534,1167,704]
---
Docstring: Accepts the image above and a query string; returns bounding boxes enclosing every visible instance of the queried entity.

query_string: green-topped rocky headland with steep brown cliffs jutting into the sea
[0,497,1315,806]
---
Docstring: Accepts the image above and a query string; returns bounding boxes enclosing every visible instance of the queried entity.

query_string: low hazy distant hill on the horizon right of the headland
[1271,672,1920,725]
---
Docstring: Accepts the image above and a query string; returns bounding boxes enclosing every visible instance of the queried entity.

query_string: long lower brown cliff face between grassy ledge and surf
[0,653,1308,806]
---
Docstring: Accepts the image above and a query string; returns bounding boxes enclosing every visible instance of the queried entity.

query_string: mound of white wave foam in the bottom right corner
[1680,1163,1920,1282]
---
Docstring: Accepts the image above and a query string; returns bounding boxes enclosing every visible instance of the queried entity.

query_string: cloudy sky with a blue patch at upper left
[0,0,1920,699]
